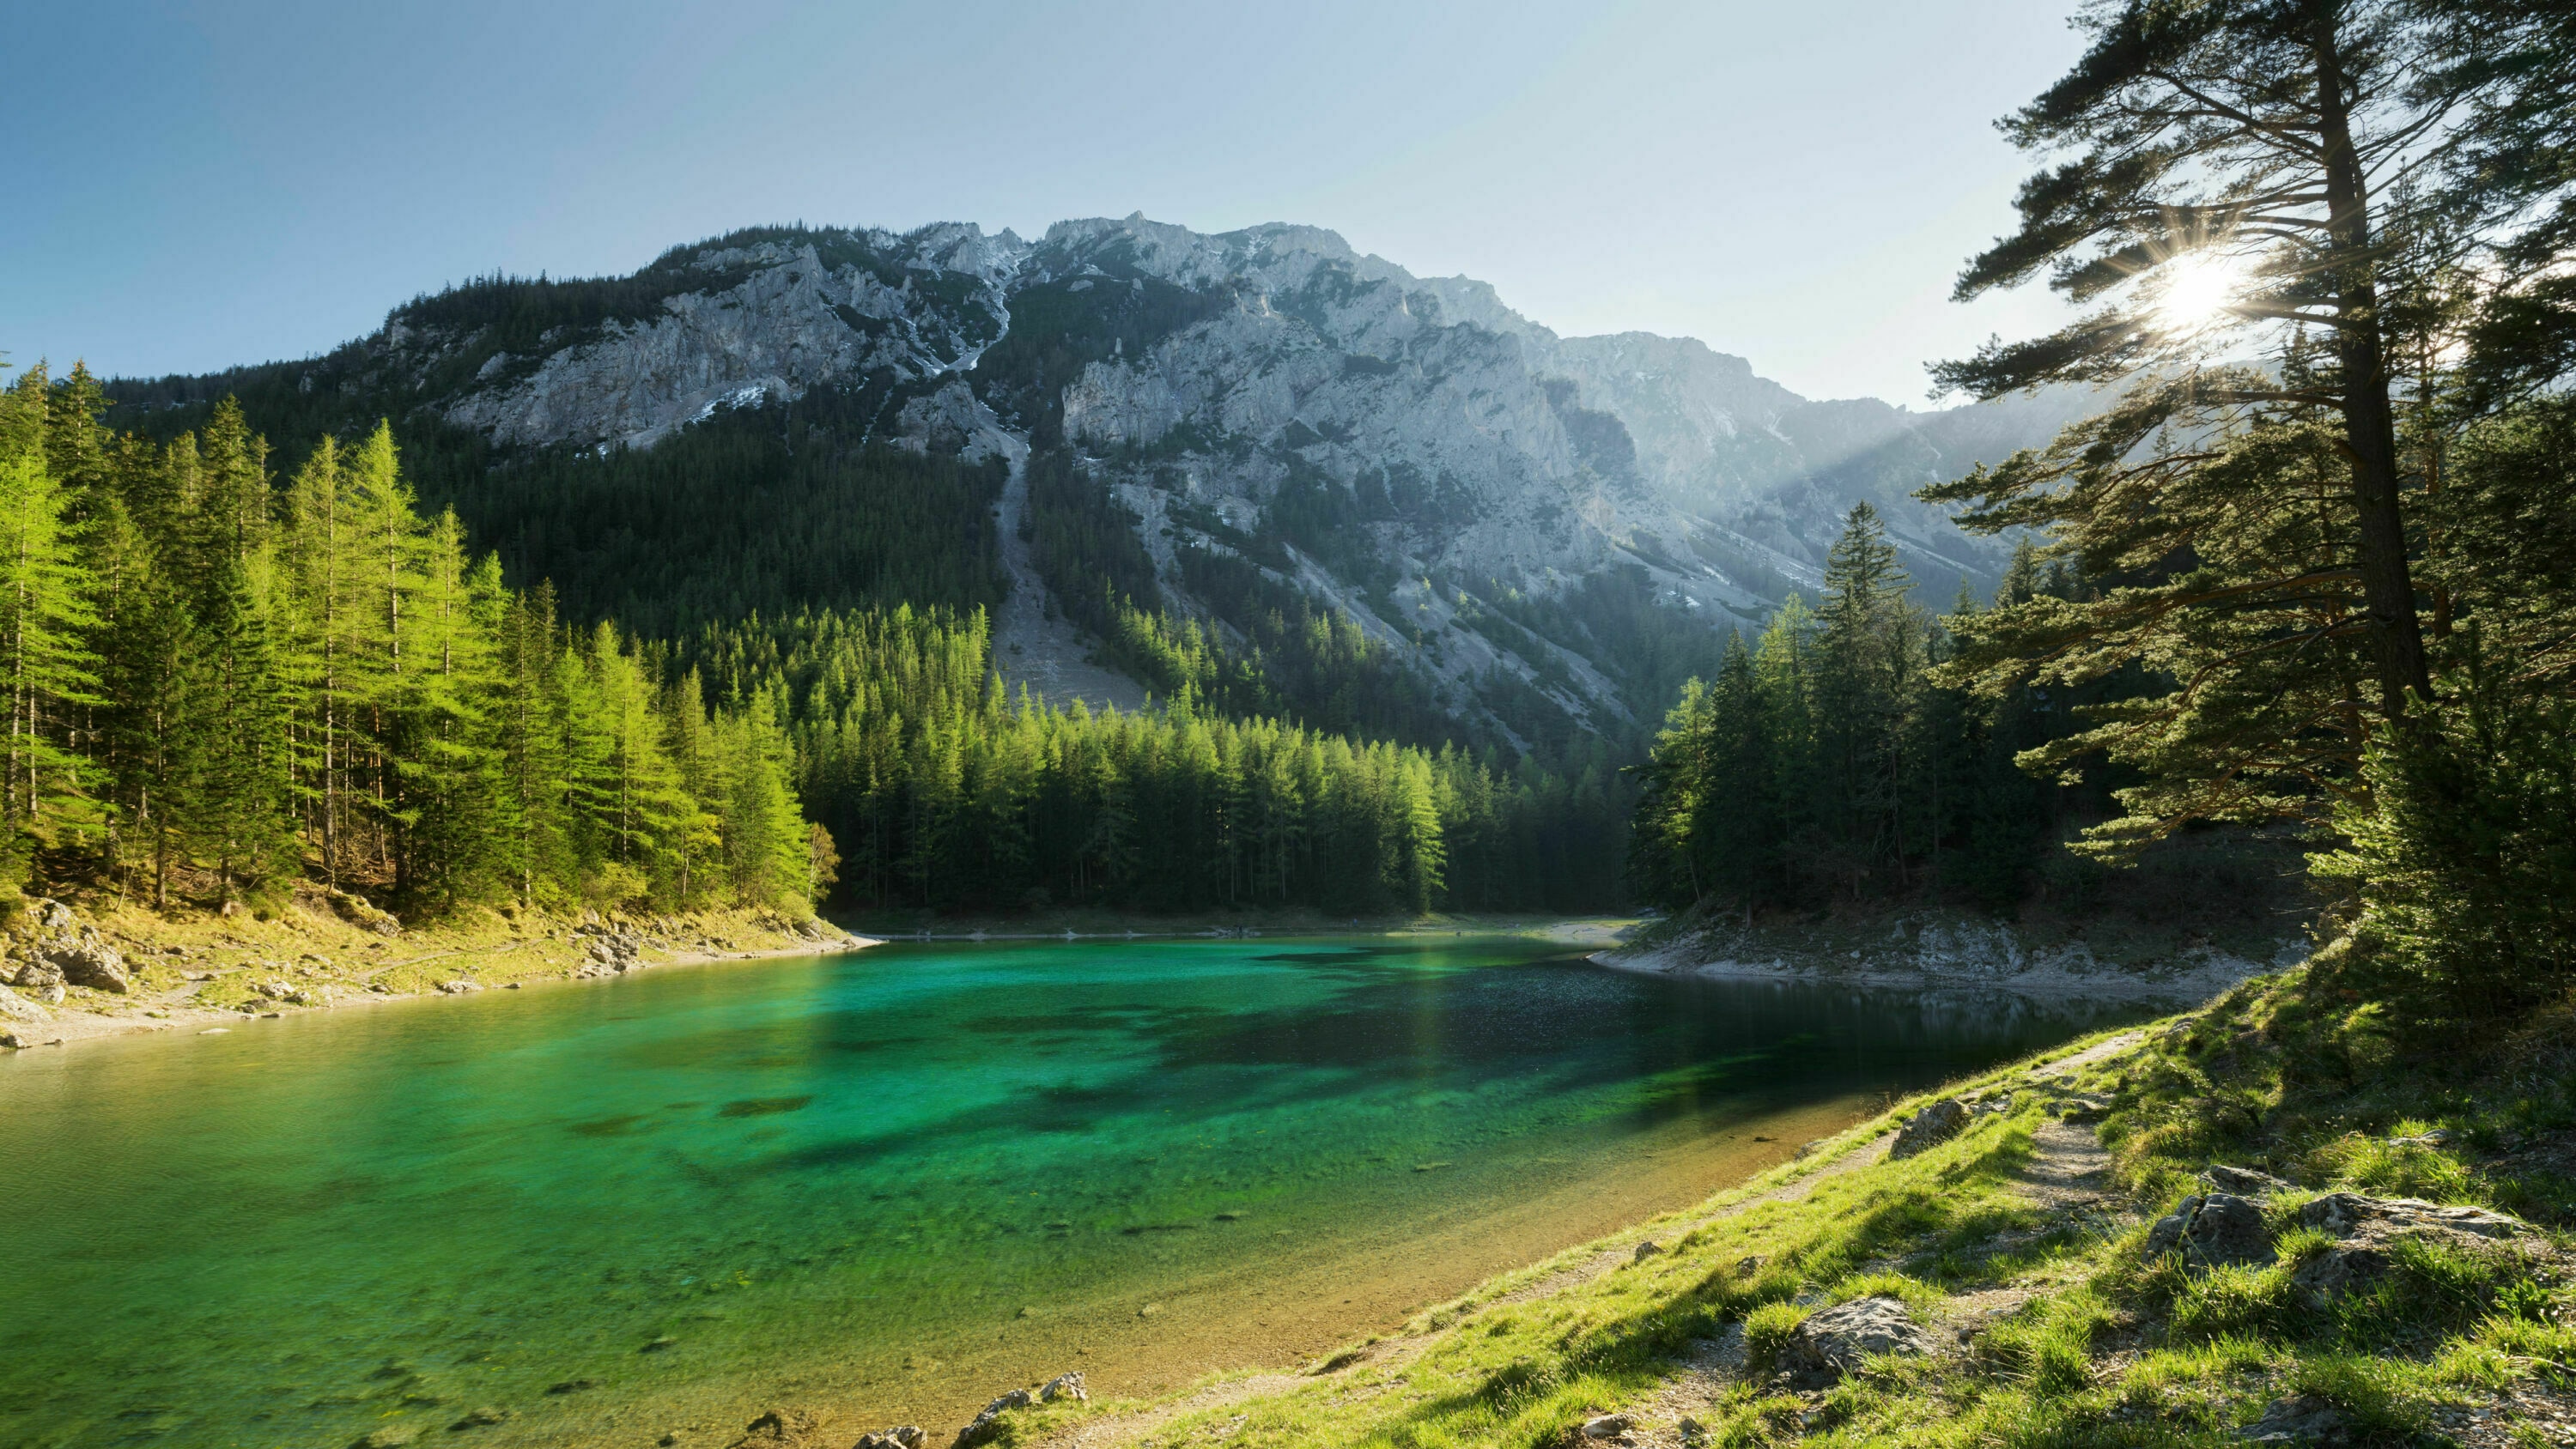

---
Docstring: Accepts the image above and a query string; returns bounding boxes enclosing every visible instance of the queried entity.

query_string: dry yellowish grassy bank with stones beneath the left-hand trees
[0,885,848,1045]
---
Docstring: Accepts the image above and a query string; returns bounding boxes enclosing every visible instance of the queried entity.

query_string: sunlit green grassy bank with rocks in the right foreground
[933,967,2576,1449]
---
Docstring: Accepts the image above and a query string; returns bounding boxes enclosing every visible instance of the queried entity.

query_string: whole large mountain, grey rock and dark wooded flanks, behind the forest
[113,216,2081,746]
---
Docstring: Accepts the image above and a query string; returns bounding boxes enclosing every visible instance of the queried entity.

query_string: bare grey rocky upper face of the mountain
[131,216,2074,724]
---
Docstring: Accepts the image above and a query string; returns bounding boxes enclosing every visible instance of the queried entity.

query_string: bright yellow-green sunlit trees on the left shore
[0,371,811,911]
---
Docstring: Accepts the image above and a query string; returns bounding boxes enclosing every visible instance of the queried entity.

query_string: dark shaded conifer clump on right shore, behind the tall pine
[1628,505,2125,913]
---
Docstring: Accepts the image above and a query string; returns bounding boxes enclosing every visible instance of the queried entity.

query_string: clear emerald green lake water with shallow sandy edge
[0,937,2143,1446]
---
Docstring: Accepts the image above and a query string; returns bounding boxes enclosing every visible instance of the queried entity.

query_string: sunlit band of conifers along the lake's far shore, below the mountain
[680,608,1607,911]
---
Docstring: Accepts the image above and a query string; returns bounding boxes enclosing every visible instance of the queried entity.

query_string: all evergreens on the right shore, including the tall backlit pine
[1631,3,2576,1027]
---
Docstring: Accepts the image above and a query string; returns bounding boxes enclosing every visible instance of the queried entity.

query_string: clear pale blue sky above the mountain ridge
[0,0,2079,404]
